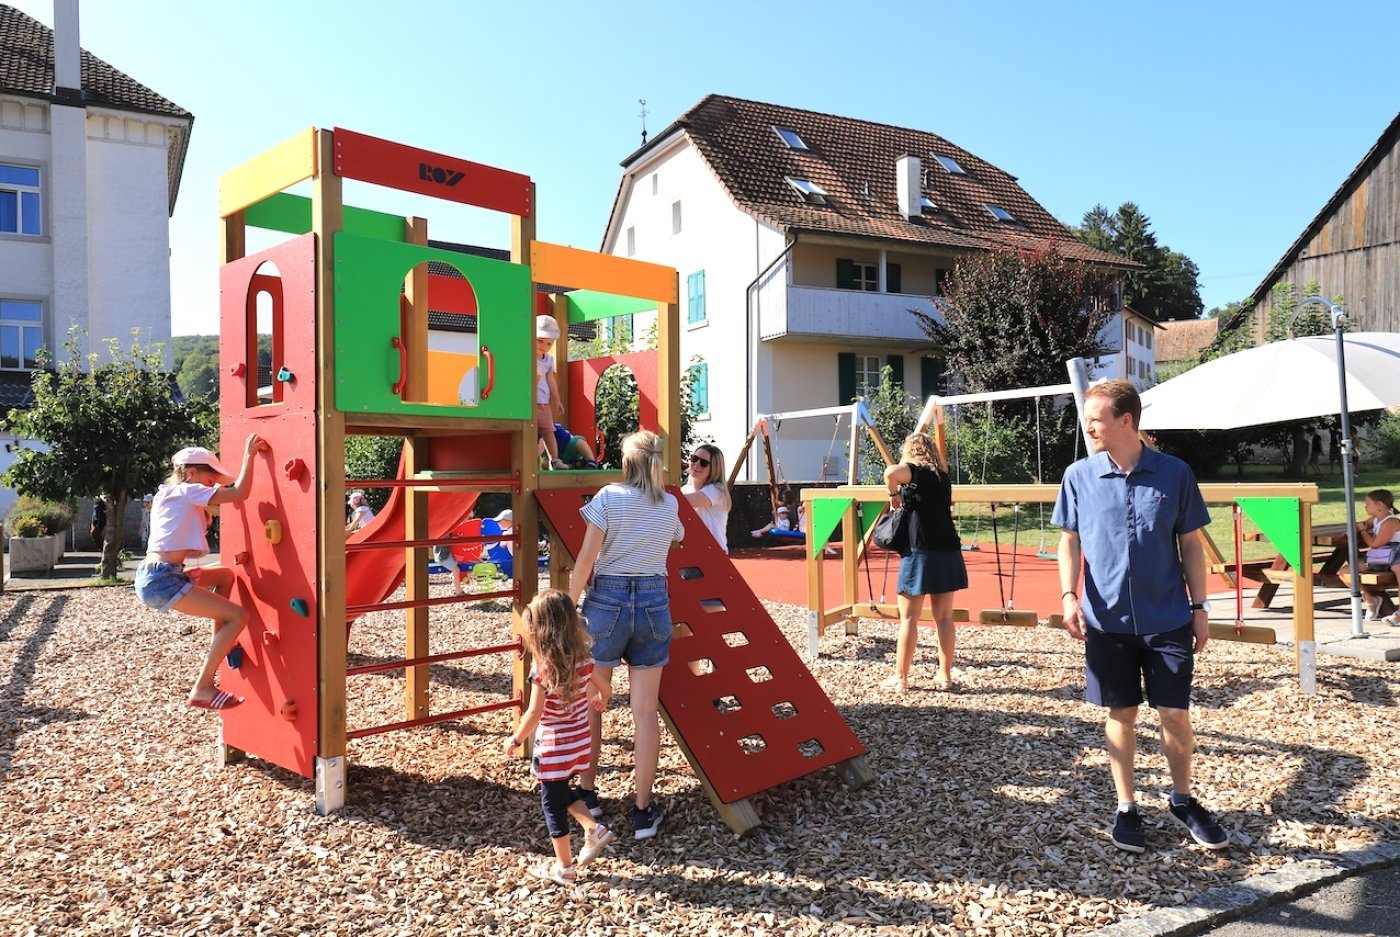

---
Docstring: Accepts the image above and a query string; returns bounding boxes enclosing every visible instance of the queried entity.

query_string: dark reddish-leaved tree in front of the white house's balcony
[914,249,1117,476]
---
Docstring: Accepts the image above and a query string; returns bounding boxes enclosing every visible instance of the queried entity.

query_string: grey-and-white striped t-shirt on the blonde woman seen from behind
[578,485,685,576]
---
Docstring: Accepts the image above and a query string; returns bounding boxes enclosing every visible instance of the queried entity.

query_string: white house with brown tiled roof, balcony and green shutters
[602,95,1124,480]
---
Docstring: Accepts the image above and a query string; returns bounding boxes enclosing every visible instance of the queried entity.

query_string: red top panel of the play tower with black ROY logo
[335,127,535,218]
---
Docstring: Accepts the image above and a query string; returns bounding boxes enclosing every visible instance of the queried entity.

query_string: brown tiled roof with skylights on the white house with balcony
[613,94,1135,266]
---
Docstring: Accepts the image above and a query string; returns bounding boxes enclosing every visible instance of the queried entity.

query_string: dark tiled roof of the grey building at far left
[0,4,195,120]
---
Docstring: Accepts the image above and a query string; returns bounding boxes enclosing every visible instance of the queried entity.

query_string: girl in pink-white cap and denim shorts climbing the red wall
[136,433,267,709]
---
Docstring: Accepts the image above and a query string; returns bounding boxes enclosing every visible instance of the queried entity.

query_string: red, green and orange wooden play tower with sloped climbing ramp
[208,127,869,832]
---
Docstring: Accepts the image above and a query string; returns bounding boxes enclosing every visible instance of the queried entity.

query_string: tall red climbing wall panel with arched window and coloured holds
[210,234,318,777]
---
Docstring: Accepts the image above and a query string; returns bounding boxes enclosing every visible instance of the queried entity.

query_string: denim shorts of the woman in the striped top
[584,576,671,669]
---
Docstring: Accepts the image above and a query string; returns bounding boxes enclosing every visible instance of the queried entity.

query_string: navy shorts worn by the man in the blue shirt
[1084,625,1196,709]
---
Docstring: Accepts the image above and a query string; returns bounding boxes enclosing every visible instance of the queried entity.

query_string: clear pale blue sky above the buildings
[8,0,1400,335]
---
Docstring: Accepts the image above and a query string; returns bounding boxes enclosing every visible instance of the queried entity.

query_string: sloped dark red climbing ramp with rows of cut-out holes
[535,487,865,804]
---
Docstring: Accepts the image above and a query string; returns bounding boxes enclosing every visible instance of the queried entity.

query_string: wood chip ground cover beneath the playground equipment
[0,587,1400,934]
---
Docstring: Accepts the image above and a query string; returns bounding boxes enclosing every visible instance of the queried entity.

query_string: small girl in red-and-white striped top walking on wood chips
[503,588,613,885]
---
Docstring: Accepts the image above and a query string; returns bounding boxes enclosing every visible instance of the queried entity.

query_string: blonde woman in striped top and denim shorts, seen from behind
[570,431,685,839]
